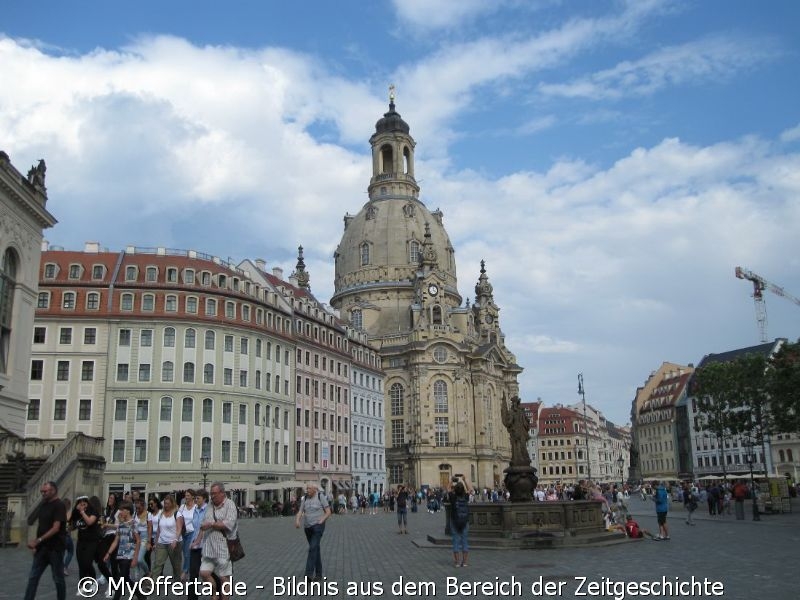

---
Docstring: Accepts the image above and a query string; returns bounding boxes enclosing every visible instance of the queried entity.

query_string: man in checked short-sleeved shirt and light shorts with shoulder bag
[195,481,239,600]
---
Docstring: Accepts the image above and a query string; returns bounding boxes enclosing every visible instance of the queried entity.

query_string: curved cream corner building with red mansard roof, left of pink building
[25,243,295,491]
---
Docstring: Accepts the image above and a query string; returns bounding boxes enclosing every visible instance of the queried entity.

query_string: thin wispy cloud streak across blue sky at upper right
[539,36,779,100]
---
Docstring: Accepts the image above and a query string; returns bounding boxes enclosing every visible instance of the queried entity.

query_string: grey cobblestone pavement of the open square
[0,498,800,600]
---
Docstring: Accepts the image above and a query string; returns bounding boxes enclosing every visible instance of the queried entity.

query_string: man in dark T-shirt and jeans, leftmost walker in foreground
[25,481,67,600]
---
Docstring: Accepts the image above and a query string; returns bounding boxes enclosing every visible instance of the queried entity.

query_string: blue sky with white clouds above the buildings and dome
[0,0,800,424]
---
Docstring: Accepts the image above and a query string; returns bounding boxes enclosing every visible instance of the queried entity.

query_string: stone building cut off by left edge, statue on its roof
[0,151,56,438]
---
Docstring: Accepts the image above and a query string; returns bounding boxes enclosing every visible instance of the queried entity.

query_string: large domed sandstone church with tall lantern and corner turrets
[331,95,522,488]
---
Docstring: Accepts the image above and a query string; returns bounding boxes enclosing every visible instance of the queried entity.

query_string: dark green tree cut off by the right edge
[767,341,800,433]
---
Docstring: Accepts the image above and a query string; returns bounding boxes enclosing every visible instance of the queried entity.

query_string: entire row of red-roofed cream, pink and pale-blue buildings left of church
[24,243,386,500]
